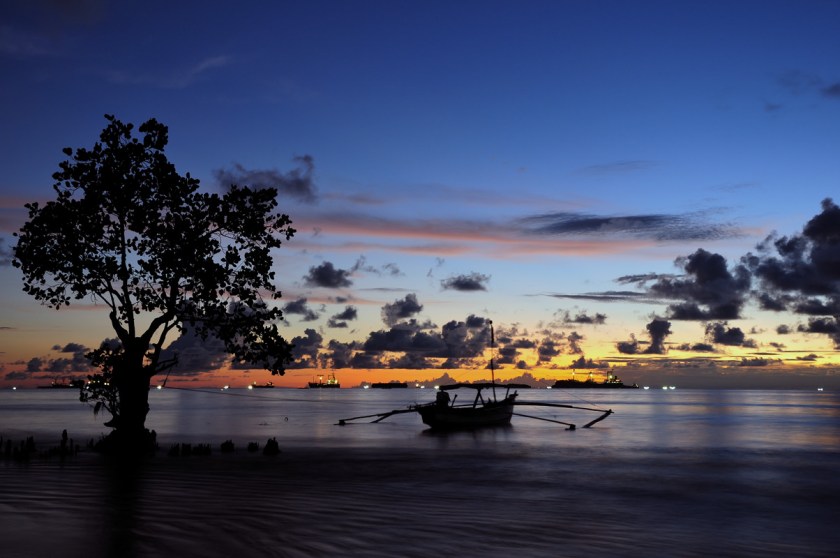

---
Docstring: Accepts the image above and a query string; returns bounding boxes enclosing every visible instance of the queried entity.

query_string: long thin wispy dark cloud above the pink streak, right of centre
[519,212,740,241]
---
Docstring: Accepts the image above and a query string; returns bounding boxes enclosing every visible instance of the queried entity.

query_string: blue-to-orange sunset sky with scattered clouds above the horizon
[0,0,840,387]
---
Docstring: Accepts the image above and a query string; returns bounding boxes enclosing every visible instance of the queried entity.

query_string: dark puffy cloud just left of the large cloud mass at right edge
[635,248,751,320]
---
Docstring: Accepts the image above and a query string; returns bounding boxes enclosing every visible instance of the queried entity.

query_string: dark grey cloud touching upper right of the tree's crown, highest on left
[213,155,318,203]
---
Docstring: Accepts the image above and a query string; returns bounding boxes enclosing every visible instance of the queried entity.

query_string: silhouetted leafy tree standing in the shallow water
[13,115,295,452]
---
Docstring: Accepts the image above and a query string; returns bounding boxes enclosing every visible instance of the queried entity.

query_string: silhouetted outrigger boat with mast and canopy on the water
[338,322,613,430]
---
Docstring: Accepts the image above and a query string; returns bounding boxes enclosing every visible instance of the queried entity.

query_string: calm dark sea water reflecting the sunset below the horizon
[0,389,840,557]
